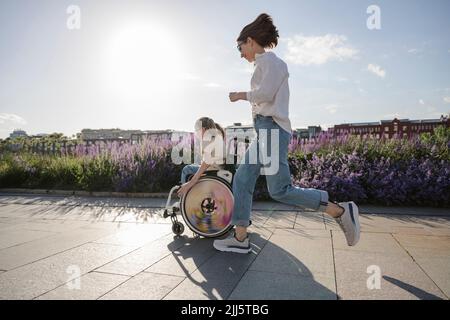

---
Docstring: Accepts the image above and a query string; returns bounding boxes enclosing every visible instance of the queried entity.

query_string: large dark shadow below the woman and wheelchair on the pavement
[168,233,337,300]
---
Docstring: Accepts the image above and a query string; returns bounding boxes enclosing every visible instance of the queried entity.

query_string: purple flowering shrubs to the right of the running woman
[289,127,450,207]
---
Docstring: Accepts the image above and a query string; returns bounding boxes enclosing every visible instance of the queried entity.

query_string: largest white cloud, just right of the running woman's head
[282,34,358,66]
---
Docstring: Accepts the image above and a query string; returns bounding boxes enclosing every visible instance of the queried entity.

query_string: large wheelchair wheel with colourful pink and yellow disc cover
[180,175,234,238]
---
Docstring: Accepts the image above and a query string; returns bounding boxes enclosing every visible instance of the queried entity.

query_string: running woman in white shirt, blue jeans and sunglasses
[214,13,360,253]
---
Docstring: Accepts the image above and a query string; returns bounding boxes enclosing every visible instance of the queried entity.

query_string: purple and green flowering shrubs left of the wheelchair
[0,140,182,192]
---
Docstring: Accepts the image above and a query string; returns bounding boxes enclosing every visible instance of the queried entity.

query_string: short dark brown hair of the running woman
[237,13,280,48]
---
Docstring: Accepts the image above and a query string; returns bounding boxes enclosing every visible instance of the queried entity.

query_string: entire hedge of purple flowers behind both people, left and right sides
[0,127,450,207]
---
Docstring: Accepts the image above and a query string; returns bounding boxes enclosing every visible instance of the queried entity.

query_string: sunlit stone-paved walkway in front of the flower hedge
[0,194,450,299]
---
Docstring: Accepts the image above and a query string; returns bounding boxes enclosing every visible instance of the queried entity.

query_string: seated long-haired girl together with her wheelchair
[164,117,234,237]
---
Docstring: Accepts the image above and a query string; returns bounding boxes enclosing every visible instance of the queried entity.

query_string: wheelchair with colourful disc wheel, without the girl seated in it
[163,169,234,238]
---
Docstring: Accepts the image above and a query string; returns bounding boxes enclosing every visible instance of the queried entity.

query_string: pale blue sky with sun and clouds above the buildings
[0,0,450,138]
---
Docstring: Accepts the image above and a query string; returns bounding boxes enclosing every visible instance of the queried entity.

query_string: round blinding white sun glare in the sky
[107,24,182,99]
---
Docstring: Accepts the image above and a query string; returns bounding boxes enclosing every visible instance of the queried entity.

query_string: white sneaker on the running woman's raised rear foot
[335,201,360,246]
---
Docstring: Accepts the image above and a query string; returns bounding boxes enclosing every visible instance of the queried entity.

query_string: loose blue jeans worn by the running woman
[231,114,328,227]
